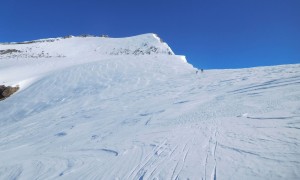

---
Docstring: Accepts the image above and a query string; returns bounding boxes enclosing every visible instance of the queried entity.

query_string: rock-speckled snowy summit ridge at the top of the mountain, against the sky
[0,34,174,59]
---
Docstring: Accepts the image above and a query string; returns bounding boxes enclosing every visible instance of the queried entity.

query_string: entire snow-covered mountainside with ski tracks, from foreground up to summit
[0,34,300,180]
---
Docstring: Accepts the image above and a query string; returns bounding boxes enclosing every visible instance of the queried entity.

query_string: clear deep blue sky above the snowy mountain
[0,0,300,69]
